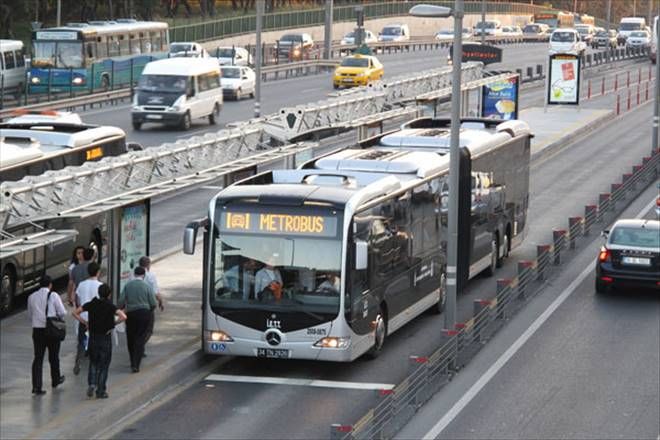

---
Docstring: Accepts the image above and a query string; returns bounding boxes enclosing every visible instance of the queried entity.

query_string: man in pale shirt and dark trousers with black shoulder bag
[28,275,66,396]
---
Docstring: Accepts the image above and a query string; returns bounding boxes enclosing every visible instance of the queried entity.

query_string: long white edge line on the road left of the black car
[422,199,660,440]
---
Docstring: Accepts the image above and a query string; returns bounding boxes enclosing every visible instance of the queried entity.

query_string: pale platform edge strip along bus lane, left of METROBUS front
[27,336,223,438]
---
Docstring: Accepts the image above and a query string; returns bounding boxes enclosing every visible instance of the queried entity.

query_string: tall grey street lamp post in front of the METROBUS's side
[409,0,462,330]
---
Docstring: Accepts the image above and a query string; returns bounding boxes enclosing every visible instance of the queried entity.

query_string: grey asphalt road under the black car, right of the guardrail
[398,186,660,440]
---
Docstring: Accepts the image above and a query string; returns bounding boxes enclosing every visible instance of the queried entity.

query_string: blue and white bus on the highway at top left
[29,19,169,93]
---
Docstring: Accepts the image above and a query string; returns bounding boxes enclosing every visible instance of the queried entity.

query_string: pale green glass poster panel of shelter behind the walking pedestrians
[119,202,149,292]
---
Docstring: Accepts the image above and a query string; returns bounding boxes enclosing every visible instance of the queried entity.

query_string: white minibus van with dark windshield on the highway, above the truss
[131,58,222,130]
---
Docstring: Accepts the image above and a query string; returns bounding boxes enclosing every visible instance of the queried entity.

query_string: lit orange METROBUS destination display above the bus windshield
[220,211,337,237]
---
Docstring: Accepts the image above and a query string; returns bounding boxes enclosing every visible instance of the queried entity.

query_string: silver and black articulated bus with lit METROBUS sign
[184,119,531,362]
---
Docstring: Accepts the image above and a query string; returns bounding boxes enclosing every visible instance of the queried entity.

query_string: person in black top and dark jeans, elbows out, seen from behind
[73,284,126,399]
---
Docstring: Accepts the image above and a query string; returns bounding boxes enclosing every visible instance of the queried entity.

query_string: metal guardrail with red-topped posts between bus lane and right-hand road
[330,149,660,440]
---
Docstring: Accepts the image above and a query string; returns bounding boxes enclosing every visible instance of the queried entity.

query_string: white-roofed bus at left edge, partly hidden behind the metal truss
[0,112,139,315]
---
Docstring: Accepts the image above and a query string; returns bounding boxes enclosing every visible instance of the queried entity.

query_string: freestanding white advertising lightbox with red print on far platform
[548,54,580,105]
